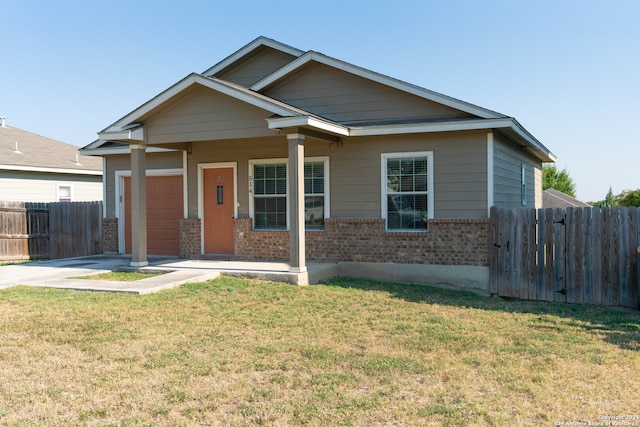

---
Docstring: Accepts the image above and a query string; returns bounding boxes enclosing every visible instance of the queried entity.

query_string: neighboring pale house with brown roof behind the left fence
[0,117,102,202]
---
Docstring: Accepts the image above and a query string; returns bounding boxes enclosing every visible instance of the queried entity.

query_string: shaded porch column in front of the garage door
[131,144,149,267]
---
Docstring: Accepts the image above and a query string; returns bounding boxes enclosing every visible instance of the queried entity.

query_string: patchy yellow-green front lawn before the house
[0,277,640,426]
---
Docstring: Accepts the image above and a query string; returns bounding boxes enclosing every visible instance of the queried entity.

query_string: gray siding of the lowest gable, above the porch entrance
[144,85,275,143]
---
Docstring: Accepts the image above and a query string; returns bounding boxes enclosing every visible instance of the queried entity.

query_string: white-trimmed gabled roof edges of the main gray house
[83,37,555,162]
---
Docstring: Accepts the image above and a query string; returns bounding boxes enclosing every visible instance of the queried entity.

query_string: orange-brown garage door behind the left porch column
[124,175,184,255]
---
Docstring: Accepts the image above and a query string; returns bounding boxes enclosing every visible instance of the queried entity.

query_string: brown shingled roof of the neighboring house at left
[0,126,102,175]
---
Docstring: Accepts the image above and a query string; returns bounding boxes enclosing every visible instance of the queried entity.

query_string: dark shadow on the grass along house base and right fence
[323,277,640,351]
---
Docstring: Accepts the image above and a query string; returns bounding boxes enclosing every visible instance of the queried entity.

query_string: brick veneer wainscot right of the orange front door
[235,218,489,267]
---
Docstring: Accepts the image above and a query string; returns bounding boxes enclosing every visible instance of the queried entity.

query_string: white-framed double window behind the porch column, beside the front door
[249,157,329,230]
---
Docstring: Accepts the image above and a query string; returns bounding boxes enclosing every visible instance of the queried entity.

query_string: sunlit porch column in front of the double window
[287,133,307,273]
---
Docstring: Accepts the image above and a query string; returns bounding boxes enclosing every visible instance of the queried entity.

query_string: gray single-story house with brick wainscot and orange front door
[81,37,555,290]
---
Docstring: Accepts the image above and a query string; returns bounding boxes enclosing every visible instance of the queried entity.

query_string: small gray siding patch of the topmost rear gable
[215,46,296,87]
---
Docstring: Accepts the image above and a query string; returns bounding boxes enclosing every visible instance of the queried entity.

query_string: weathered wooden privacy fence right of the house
[489,207,640,308]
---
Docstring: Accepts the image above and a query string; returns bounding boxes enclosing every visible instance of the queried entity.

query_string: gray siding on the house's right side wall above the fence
[494,135,542,208]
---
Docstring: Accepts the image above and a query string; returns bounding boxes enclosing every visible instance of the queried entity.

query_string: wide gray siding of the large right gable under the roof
[265,63,472,124]
